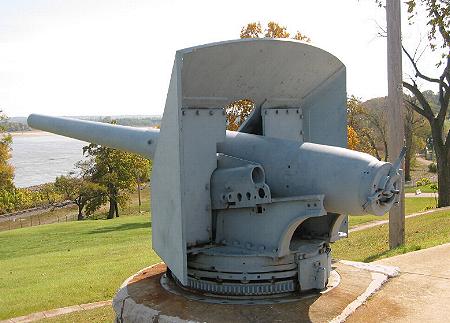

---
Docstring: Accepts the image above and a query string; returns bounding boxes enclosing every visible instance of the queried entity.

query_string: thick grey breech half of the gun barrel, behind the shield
[218,132,395,215]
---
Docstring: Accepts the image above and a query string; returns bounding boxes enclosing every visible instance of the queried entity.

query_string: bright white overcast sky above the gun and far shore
[0,0,442,117]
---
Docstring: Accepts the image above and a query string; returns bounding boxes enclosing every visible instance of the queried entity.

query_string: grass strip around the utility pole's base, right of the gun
[331,210,450,262]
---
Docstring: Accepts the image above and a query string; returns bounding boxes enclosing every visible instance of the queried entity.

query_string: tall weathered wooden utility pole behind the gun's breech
[386,0,405,249]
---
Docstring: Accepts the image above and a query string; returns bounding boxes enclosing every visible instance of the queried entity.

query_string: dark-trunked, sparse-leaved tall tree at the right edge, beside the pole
[403,0,450,207]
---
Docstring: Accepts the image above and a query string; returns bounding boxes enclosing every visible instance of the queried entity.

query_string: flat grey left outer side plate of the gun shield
[151,60,187,284]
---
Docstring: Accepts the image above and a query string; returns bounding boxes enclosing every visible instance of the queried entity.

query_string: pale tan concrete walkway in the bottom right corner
[347,243,450,323]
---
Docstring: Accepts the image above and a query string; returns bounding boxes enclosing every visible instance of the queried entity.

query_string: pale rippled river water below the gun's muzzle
[11,133,87,187]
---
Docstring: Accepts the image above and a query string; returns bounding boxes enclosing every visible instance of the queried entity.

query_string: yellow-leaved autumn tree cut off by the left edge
[0,110,14,190]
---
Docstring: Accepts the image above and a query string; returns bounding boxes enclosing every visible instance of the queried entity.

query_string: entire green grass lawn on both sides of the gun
[0,190,444,322]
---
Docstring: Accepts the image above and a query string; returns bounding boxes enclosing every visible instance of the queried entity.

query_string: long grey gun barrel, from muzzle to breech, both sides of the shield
[28,114,400,215]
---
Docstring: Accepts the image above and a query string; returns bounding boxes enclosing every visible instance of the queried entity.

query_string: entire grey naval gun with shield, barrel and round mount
[28,39,402,298]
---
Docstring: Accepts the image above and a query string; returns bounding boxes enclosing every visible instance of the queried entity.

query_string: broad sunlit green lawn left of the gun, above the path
[0,213,159,320]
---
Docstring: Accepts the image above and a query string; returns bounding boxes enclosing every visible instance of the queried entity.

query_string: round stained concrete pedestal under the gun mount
[113,262,395,323]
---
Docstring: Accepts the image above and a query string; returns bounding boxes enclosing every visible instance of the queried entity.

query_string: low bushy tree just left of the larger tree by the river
[55,176,106,221]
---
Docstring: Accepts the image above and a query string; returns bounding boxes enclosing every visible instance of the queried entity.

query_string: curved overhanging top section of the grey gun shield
[177,38,345,108]
